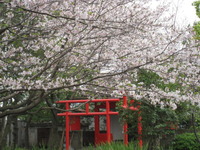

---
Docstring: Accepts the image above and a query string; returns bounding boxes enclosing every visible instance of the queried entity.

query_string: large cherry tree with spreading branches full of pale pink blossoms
[0,0,200,117]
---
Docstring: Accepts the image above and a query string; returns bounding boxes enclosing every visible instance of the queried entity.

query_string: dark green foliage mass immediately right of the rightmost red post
[141,102,177,136]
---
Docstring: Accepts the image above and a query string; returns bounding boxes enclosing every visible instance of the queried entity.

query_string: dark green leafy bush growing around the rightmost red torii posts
[118,100,178,149]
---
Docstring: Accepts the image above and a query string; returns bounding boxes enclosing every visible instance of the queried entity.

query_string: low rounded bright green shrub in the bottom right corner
[173,133,200,150]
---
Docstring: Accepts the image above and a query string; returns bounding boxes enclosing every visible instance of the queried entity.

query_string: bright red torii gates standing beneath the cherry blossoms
[56,96,142,150]
